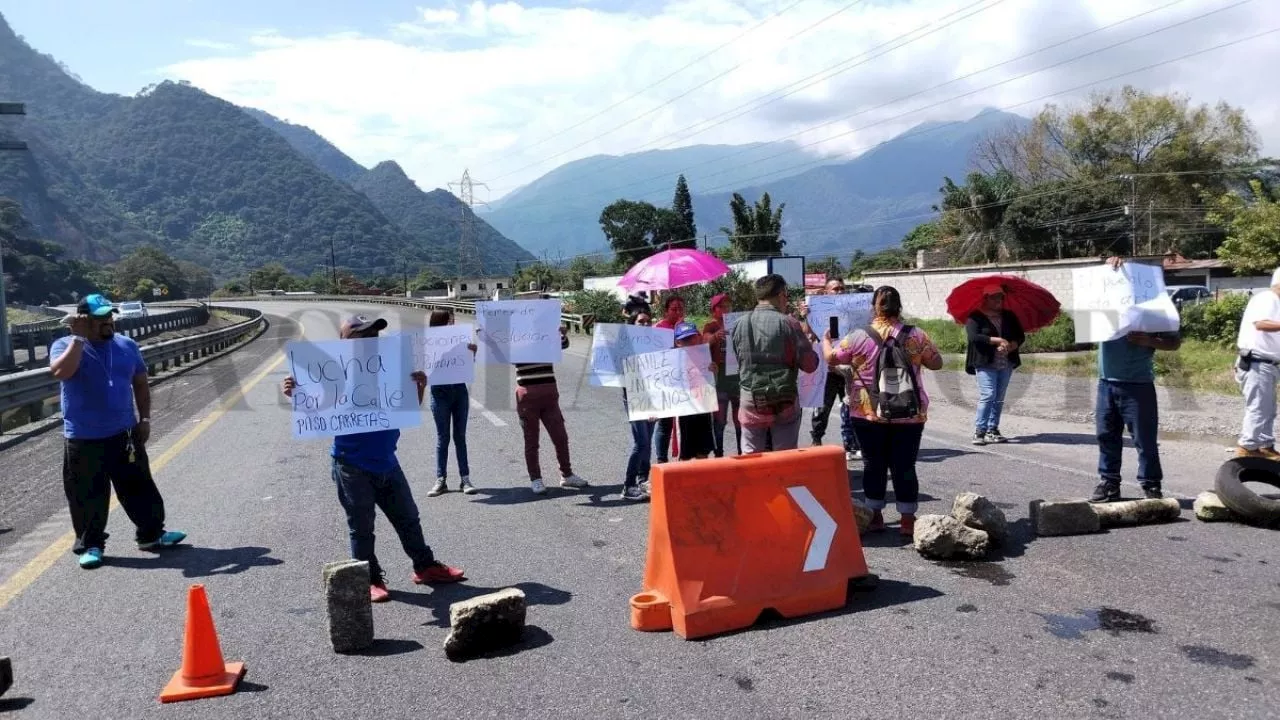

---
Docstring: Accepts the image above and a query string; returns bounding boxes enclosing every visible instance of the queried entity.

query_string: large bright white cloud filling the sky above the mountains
[166,0,1280,197]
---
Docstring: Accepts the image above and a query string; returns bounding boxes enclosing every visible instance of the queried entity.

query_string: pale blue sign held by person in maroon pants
[476,300,562,365]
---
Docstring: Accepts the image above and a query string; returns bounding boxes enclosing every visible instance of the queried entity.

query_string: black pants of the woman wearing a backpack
[854,418,924,515]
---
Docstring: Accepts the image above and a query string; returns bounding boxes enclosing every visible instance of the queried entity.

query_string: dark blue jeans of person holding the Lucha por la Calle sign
[333,460,435,583]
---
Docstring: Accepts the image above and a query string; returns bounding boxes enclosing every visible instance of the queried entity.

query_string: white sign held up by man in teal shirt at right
[1071,263,1180,343]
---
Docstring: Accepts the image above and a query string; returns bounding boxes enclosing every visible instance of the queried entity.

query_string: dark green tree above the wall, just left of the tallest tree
[933,170,1018,261]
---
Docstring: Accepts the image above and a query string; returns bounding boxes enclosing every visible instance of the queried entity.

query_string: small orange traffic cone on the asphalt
[160,584,244,702]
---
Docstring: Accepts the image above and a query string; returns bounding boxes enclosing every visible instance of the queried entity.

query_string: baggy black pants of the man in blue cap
[63,433,164,555]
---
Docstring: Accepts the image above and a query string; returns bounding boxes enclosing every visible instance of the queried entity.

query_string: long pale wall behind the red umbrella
[863,258,1162,320]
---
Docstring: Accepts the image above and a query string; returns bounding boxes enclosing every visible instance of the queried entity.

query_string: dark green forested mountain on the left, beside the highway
[0,18,532,279]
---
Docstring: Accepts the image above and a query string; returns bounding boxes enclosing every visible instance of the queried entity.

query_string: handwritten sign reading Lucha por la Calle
[284,334,421,438]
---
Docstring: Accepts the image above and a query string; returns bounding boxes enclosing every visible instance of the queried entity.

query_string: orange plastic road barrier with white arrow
[631,446,868,639]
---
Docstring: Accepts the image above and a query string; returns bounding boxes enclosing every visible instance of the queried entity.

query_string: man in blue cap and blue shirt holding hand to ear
[49,295,187,569]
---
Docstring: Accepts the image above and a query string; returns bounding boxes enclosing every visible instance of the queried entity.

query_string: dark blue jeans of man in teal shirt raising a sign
[1093,380,1165,488]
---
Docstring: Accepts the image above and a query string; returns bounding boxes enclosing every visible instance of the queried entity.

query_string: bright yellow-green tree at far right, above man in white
[1206,181,1280,275]
